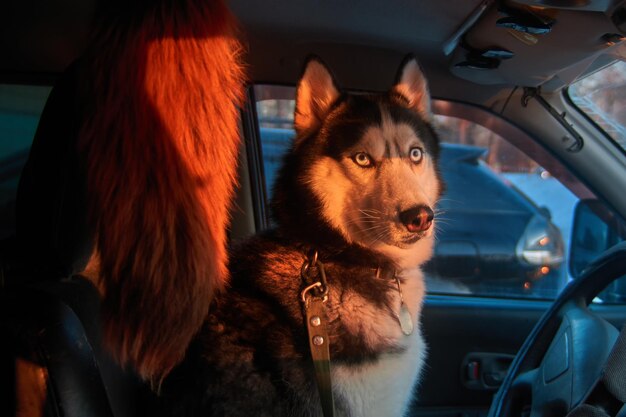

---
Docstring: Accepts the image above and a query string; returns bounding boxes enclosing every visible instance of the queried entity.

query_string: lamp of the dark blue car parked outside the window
[517,216,563,267]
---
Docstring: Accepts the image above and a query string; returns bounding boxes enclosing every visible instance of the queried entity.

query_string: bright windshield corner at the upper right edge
[568,61,626,149]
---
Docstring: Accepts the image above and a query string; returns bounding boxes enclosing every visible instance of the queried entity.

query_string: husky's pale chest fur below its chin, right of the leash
[332,269,426,417]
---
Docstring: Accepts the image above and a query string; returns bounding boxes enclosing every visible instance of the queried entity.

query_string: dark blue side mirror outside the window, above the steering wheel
[569,199,626,280]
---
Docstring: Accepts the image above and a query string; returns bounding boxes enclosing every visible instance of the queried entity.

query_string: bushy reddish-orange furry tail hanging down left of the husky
[80,0,244,380]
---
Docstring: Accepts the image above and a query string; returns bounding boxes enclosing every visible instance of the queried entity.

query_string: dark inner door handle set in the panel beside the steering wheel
[461,352,515,390]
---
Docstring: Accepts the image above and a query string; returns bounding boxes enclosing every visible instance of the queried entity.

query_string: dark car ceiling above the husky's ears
[0,0,626,104]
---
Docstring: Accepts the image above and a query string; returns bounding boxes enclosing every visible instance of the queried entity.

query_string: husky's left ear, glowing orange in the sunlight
[294,58,340,134]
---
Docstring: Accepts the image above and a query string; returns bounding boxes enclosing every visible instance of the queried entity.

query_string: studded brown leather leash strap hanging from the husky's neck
[301,251,335,417]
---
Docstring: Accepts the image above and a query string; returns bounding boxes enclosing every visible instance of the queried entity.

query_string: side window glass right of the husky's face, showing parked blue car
[426,115,578,298]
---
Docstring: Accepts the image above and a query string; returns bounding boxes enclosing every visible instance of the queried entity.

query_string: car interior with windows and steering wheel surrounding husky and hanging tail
[0,0,626,417]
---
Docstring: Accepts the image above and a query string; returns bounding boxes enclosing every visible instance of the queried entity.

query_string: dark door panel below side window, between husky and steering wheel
[410,295,550,417]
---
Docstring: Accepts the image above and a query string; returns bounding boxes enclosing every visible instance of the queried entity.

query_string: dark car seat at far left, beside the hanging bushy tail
[0,61,156,417]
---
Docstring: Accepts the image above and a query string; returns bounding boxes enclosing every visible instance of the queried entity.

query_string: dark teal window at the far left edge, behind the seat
[0,84,51,239]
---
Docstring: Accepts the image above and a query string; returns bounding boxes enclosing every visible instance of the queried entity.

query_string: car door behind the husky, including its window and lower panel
[249,76,623,417]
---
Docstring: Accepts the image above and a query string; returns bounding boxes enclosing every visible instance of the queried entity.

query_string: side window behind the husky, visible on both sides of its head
[255,86,621,299]
